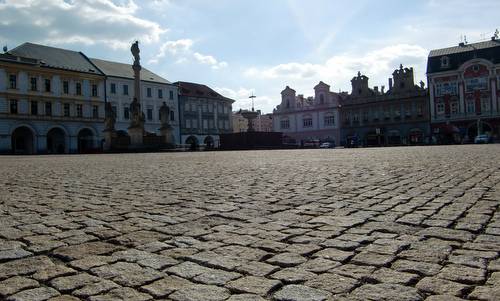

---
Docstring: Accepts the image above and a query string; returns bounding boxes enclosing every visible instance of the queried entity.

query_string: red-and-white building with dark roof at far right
[427,35,500,143]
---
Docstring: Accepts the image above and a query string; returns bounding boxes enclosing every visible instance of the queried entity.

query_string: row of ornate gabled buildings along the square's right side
[272,35,500,146]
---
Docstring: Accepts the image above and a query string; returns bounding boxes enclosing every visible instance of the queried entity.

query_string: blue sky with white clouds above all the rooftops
[0,0,500,113]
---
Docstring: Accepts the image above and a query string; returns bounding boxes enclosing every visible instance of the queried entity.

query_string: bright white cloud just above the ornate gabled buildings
[245,44,429,89]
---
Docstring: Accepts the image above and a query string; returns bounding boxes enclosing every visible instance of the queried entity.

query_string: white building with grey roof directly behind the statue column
[91,59,181,144]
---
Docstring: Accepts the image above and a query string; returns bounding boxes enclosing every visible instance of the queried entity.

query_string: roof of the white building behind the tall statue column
[90,58,170,84]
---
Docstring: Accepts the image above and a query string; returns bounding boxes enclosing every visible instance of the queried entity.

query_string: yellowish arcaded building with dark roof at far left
[0,43,105,154]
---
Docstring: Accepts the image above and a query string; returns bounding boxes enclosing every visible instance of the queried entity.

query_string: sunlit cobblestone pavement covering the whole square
[0,145,500,301]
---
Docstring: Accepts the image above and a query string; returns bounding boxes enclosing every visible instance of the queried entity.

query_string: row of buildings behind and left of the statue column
[0,43,234,154]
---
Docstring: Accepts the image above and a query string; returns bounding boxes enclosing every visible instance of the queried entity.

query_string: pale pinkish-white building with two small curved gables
[272,82,340,145]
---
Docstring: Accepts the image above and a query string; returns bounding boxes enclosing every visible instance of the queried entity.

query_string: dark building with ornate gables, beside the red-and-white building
[341,65,429,147]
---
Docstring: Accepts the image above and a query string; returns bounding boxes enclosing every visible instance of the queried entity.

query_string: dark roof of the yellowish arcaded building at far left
[9,43,102,75]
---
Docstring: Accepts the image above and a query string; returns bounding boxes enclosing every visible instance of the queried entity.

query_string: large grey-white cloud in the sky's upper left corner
[0,0,167,49]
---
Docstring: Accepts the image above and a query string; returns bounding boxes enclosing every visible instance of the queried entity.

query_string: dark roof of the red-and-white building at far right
[427,39,500,73]
